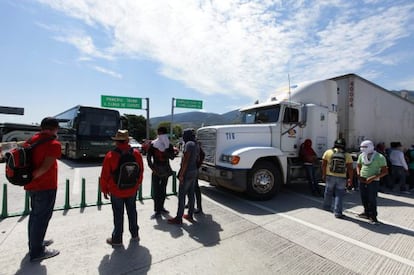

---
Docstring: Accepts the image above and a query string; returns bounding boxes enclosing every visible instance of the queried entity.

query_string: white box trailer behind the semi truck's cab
[332,74,414,149]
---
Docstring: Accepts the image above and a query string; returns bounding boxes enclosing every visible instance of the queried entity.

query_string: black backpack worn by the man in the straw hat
[113,148,141,189]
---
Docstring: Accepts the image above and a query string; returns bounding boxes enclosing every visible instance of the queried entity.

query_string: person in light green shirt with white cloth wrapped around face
[356,140,388,224]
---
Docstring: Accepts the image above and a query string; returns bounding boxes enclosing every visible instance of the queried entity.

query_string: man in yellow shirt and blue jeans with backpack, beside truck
[322,138,354,219]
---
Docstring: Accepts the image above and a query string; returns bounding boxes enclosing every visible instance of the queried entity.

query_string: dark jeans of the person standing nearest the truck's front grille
[177,170,198,219]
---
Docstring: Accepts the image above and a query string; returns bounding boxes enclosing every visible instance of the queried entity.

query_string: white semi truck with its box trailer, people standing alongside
[197,74,414,200]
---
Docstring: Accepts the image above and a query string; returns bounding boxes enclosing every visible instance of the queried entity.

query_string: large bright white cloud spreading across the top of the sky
[40,0,414,99]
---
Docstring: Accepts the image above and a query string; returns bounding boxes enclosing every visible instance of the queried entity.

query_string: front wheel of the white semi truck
[247,161,280,200]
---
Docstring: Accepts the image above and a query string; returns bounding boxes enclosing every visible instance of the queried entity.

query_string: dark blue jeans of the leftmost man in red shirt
[28,189,57,258]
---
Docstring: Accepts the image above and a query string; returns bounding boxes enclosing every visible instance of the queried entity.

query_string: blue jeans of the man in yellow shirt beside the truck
[323,176,346,216]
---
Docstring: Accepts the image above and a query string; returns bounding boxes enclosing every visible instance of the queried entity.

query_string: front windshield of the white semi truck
[242,105,280,124]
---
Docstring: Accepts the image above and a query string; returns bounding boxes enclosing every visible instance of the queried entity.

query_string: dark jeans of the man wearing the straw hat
[111,195,139,243]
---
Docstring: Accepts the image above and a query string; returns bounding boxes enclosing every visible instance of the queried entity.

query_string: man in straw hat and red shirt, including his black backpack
[99,130,144,247]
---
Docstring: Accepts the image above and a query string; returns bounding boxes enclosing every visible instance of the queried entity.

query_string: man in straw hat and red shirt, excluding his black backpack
[99,130,144,246]
